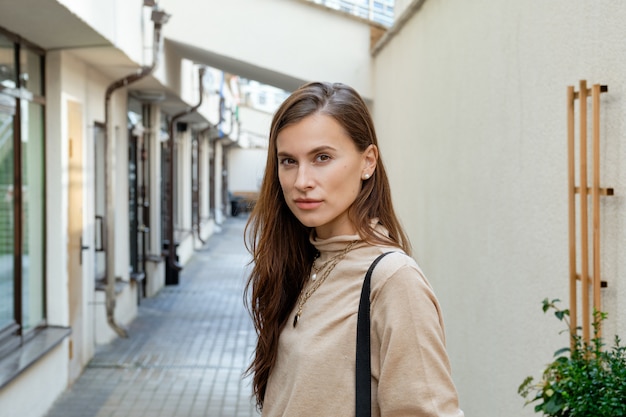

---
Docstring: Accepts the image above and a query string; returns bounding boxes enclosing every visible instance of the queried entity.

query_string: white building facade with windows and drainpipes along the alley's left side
[0,1,258,416]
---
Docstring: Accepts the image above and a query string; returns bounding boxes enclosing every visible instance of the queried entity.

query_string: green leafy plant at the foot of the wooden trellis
[518,298,626,417]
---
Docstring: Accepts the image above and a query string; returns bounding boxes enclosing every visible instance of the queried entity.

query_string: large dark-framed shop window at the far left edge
[0,26,51,364]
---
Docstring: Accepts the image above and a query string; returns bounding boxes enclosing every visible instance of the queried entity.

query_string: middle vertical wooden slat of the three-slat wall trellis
[578,80,590,341]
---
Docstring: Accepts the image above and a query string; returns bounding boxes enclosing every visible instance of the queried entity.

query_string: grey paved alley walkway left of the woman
[46,217,258,417]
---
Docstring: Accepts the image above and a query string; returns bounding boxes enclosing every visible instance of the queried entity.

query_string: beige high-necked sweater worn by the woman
[263,229,463,417]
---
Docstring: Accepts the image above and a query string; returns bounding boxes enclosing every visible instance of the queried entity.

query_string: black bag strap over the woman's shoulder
[356,252,391,417]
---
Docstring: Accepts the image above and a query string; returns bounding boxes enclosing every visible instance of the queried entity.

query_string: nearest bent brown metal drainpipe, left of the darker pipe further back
[104,7,170,337]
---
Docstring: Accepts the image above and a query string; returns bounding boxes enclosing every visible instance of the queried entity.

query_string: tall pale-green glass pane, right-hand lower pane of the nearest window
[21,102,45,330]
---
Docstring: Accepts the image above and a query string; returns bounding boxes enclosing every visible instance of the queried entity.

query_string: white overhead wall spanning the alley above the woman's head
[159,0,371,97]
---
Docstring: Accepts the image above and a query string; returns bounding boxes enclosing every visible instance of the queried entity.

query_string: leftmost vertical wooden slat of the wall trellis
[567,86,582,345]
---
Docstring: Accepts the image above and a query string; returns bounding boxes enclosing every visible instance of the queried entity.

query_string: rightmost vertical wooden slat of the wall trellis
[591,84,602,330]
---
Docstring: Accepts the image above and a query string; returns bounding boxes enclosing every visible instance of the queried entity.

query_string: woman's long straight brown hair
[245,82,410,409]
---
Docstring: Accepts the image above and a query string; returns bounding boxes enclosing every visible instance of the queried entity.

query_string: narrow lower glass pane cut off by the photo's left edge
[0,101,15,331]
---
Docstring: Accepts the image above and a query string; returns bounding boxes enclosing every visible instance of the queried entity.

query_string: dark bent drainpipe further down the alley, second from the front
[165,67,206,280]
